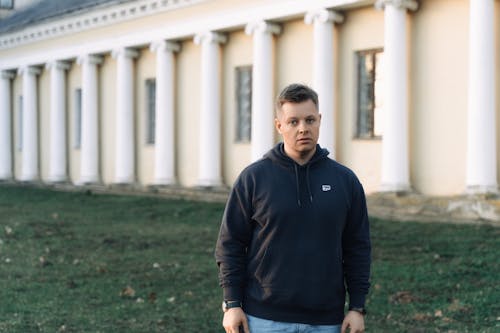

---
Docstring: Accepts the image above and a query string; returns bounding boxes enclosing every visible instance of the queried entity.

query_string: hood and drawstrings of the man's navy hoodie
[264,142,329,207]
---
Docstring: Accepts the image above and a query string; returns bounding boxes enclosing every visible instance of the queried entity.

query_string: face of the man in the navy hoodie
[274,100,321,161]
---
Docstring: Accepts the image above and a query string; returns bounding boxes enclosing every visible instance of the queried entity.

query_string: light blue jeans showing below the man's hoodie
[247,315,341,333]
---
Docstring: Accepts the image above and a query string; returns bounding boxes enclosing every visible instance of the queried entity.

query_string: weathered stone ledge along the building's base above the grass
[0,181,500,226]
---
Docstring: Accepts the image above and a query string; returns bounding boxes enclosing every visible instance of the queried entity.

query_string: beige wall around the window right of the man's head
[336,7,384,193]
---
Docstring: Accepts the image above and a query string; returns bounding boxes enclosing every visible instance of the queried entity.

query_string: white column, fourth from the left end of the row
[78,55,102,184]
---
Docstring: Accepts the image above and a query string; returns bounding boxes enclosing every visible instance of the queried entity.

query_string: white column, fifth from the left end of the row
[112,48,139,184]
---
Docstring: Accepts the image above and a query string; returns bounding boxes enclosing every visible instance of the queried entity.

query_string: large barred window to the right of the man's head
[356,49,384,139]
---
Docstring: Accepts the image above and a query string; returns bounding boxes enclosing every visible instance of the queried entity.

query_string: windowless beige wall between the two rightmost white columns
[410,0,469,195]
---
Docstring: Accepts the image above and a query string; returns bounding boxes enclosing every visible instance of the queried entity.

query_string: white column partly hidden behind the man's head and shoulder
[305,9,344,158]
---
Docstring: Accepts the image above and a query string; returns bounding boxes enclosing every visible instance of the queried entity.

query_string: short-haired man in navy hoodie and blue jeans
[215,84,371,333]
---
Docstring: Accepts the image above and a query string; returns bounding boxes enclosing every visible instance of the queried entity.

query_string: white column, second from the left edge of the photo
[19,66,41,181]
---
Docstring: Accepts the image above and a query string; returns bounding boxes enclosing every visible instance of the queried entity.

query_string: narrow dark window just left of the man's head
[236,66,252,142]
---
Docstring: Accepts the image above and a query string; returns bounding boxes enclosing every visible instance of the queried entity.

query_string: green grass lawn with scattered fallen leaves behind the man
[0,185,500,333]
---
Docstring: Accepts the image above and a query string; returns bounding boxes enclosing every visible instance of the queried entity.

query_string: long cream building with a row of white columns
[0,0,500,196]
